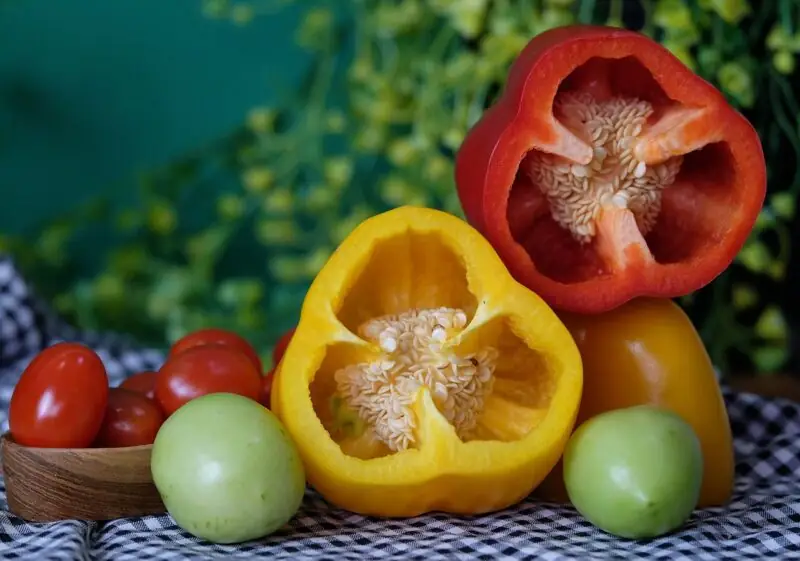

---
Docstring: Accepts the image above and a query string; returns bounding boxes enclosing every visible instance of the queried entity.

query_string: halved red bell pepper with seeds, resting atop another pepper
[456,26,766,313]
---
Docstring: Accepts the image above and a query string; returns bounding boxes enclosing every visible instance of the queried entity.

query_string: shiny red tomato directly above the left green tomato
[156,345,261,416]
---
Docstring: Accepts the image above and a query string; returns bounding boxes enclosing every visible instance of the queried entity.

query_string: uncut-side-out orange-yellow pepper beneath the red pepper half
[537,298,735,507]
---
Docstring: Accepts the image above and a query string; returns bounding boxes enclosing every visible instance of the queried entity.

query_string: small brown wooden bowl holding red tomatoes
[0,433,166,522]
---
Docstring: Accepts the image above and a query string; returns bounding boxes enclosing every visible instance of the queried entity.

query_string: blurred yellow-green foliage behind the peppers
[0,0,800,372]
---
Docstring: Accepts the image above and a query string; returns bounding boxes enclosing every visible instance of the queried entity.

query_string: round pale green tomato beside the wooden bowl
[150,393,305,543]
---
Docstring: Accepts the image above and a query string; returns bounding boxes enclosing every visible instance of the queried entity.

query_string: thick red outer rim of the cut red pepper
[455,25,766,313]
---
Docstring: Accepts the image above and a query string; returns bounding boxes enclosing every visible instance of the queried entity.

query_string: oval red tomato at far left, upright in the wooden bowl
[8,343,108,448]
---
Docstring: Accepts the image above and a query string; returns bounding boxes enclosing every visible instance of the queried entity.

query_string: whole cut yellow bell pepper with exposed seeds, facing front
[271,207,582,517]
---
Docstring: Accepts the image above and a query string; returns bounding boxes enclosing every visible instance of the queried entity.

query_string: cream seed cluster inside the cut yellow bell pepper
[334,307,497,451]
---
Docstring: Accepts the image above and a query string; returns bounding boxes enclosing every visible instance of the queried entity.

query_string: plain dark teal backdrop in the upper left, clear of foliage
[0,0,305,233]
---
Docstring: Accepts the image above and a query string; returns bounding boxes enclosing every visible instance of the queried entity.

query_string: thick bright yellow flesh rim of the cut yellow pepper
[271,207,582,517]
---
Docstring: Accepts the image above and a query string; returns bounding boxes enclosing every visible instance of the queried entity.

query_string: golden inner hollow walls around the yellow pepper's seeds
[310,232,555,459]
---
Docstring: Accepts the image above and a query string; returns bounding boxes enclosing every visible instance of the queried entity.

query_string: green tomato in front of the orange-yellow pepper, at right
[564,406,703,539]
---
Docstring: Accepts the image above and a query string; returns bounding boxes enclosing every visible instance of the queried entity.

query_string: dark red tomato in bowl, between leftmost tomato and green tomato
[94,388,164,448]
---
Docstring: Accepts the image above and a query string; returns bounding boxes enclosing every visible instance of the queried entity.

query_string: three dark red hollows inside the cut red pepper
[507,57,736,283]
